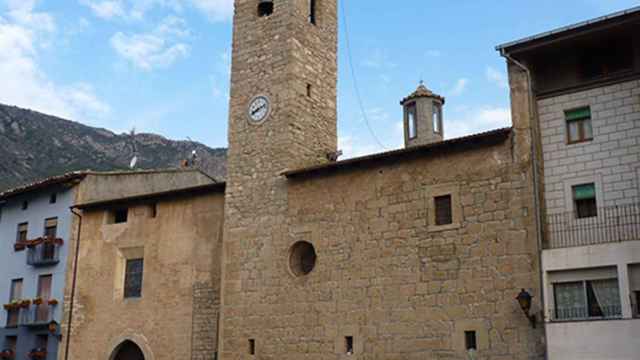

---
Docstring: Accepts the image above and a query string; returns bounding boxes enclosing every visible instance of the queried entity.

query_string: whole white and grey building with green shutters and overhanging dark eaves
[498,8,640,360]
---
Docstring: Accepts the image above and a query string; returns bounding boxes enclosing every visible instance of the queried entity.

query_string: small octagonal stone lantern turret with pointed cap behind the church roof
[400,82,444,147]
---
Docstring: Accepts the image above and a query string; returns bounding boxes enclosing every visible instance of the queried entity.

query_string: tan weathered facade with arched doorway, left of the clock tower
[59,178,224,360]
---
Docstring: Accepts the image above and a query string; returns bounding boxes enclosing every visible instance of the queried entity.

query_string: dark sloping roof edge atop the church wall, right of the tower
[283,127,512,178]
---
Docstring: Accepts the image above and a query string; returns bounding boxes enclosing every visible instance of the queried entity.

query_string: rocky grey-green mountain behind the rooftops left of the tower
[0,104,227,191]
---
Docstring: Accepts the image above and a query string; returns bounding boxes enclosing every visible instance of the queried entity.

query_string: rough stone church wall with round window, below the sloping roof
[219,136,544,360]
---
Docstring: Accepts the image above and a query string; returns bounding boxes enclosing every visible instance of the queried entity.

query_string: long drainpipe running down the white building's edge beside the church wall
[500,49,549,359]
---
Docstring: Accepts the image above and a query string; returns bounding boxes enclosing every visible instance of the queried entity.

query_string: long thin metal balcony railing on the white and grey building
[544,203,640,249]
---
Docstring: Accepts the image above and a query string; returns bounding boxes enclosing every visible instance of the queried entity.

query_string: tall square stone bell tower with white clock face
[219,0,337,360]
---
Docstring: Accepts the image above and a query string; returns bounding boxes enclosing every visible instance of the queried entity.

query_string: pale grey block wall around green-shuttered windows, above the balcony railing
[538,80,640,214]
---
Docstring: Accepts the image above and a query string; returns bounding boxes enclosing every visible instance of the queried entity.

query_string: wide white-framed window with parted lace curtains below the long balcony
[551,267,622,320]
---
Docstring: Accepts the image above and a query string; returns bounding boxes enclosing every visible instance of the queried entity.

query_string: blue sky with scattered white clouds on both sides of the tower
[0,0,640,157]
